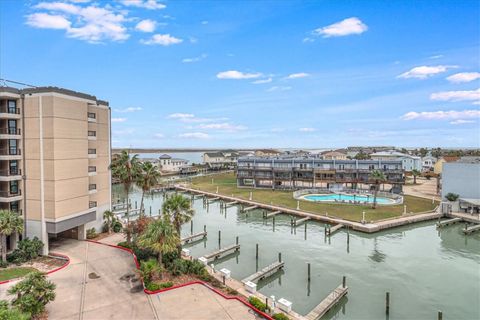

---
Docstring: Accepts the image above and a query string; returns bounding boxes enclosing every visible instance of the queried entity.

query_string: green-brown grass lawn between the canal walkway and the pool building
[192,173,438,221]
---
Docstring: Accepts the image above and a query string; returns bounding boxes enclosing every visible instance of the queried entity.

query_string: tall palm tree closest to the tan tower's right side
[110,150,141,243]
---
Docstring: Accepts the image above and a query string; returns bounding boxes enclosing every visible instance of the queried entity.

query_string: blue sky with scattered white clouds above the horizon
[0,0,480,148]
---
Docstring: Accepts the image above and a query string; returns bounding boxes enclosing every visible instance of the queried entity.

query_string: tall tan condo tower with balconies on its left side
[0,87,111,252]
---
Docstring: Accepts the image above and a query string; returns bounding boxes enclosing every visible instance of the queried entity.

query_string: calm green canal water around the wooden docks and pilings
[114,186,480,319]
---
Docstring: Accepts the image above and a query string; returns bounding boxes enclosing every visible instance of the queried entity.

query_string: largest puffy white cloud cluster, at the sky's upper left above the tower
[27,2,130,43]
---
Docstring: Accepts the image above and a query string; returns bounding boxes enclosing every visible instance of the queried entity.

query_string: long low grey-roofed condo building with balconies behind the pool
[237,157,404,193]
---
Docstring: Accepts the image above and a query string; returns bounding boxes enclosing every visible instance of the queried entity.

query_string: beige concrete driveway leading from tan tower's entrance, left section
[47,239,158,320]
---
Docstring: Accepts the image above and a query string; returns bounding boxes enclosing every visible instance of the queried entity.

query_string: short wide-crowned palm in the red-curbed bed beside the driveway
[138,216,180,266]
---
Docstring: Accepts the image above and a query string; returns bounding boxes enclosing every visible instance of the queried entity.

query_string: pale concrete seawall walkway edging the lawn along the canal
[175,185,443,233]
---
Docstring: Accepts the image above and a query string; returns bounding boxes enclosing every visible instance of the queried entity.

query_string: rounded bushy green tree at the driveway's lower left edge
[8,271,56,317]
